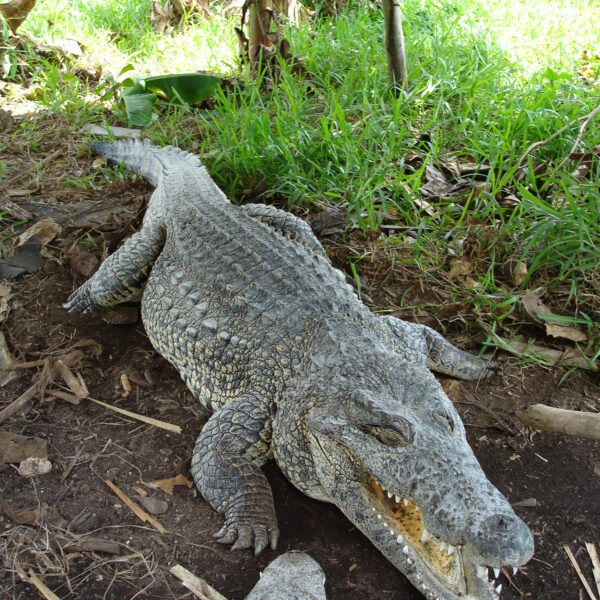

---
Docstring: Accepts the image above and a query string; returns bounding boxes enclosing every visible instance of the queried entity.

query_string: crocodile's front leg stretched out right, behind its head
[382,316,498,380]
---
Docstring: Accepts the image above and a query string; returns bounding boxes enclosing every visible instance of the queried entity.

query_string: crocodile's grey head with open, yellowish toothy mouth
[305,363,533,600]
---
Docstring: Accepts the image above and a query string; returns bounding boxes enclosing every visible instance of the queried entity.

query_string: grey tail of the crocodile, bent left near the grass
[91,140,202,186]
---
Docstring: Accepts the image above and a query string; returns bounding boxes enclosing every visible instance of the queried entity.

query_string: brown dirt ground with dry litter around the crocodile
[0,109,600,600]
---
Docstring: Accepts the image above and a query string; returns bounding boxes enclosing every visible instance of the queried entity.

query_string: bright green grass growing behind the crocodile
[5,0,600,351]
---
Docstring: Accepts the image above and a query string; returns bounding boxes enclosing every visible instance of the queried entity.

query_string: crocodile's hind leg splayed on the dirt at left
[64,227,164,313]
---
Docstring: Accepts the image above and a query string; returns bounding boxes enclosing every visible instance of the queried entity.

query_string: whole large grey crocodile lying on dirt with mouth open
[65,140,533,600]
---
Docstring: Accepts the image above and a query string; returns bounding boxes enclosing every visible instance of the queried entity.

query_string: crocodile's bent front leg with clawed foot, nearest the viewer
[192,394,279,554]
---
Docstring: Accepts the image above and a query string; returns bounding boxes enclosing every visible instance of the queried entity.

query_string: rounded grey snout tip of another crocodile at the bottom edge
[245,550,327,600]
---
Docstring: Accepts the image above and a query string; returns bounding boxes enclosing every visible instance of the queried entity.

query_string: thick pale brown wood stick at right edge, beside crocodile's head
[516,404,600,440]
